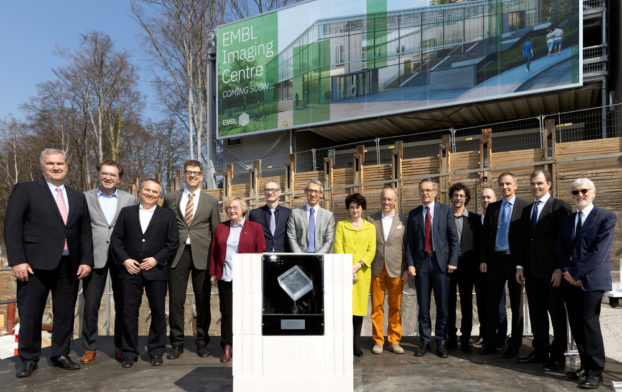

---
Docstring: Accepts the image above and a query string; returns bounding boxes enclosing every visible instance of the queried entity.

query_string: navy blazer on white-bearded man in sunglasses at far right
[557,206,617,291]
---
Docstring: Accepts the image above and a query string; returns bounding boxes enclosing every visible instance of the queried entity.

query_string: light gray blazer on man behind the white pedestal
[287,204,335,253]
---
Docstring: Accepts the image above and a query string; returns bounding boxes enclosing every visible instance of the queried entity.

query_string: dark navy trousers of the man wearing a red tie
[415,254,449,344]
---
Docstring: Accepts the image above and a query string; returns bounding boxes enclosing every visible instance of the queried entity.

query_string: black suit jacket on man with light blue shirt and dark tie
[481,197,529,266]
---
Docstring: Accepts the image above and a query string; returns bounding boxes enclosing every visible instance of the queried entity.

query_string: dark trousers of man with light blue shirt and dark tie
[484,254,523,350]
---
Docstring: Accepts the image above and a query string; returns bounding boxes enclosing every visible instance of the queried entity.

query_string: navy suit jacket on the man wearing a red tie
[406,202,460,272]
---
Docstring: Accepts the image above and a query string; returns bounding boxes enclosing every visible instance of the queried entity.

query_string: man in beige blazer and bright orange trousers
[367,188,406,354]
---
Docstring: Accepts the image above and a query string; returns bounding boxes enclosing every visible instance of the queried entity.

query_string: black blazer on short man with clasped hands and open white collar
[110,204,179,280]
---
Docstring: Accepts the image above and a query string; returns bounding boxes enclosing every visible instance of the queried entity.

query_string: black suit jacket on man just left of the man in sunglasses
[519,197,571,279]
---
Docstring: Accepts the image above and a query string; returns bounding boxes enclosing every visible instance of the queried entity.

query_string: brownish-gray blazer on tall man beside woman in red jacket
[162,190,220,270]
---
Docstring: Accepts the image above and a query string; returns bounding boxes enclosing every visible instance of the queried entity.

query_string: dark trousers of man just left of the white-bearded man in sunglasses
[525,272,568,362]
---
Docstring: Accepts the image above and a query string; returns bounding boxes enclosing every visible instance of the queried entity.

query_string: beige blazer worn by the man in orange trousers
[367,211,407,278]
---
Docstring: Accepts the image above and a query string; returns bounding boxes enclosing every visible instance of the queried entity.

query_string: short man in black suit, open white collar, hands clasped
[110,179,179,368]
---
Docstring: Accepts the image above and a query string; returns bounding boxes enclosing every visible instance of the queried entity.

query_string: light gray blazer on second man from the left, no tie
[84,188,137,268]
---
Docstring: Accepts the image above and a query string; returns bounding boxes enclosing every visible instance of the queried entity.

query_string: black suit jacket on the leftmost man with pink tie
[4,179,93,270]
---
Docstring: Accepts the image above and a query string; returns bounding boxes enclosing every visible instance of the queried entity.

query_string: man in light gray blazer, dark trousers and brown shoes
[80,160,136,363]
